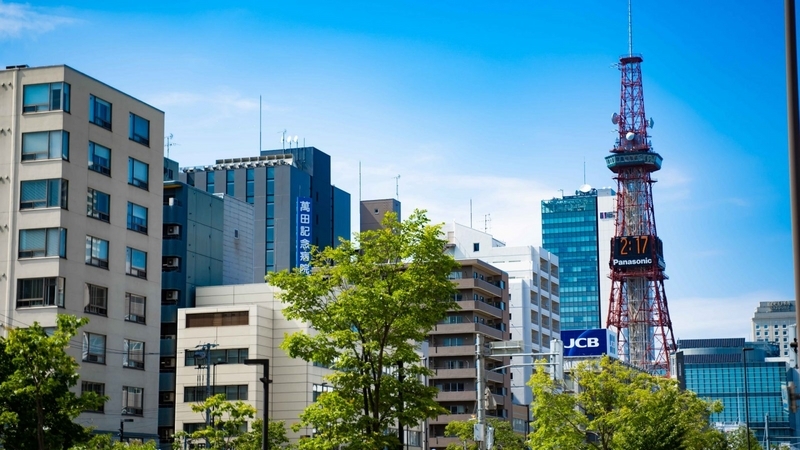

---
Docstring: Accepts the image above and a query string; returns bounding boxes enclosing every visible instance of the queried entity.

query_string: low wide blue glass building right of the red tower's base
[673,338,794,443]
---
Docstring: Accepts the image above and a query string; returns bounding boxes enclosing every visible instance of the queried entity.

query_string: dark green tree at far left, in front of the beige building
[0,314,107,450]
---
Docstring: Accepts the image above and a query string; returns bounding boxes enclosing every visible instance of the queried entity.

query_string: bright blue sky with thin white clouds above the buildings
[0,0,794,338]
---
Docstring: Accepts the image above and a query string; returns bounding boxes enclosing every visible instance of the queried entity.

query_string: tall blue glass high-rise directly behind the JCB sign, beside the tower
[542,185,616,330]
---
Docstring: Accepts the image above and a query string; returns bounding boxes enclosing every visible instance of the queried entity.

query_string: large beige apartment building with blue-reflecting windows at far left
[0,65,164,439]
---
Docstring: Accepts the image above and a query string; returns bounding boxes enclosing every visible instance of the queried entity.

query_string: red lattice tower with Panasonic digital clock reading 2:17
[606,54,675,376]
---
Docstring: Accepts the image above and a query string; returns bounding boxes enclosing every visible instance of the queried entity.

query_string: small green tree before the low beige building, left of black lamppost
[173,394,256,450]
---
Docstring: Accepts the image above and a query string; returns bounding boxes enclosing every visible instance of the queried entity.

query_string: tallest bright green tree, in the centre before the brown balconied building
[268,211,459,450]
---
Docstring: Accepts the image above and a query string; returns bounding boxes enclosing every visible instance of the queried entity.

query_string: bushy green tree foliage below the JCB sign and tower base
[529,357,724,450]
